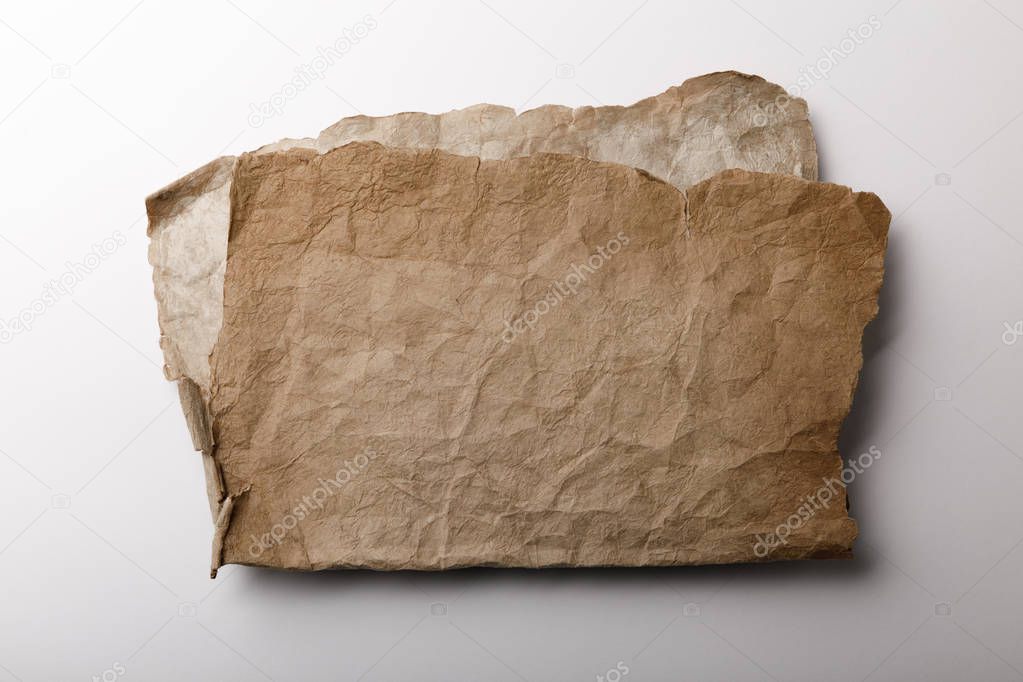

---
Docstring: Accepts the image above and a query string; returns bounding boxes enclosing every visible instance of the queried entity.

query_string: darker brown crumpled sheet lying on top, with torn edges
[203,143,889,570]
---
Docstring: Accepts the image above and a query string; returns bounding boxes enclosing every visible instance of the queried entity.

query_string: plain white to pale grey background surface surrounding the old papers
[0,0,1023,682]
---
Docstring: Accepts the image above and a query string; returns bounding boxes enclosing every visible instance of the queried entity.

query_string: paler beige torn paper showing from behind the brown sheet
[147,72,817,402]
